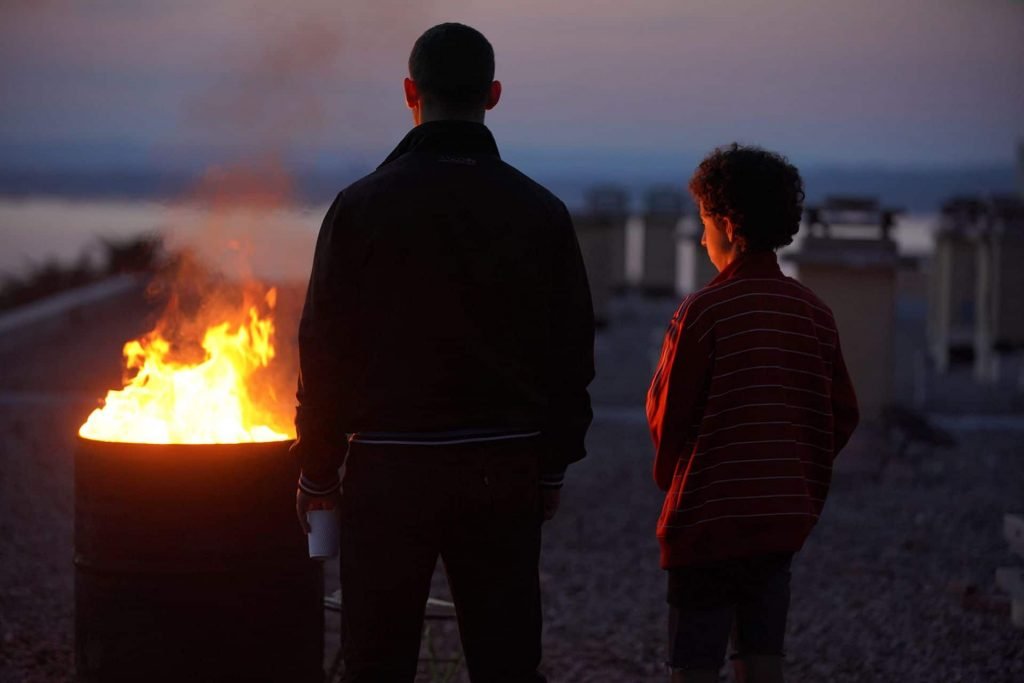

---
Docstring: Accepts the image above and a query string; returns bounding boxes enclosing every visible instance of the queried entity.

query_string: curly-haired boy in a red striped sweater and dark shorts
[647,144,858,683]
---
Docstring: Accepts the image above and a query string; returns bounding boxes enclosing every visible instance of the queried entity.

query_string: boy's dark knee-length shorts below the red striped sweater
[668,553,793,670]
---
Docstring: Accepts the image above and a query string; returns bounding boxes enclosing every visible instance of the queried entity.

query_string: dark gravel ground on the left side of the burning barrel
[0,288,150,683]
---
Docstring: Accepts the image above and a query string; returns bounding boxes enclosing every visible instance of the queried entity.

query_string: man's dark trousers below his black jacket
[341,439,545,683]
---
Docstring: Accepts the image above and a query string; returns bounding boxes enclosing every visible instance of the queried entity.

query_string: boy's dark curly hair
[689,142,804,251]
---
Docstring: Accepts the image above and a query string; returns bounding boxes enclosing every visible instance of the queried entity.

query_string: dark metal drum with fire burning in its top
[75,437,324,683]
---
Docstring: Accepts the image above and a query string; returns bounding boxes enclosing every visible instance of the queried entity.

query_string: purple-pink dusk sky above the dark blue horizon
[0,0,1024,174]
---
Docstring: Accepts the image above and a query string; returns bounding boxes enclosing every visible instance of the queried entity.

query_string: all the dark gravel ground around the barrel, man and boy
[0,290,1024,683]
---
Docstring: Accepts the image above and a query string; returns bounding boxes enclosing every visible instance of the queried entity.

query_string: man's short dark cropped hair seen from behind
[409,24,495,109]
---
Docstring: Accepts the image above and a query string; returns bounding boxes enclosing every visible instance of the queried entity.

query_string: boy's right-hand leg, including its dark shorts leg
[736,554,793,683]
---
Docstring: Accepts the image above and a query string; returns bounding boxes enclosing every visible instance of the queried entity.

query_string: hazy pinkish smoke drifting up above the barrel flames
[168,0,452,282]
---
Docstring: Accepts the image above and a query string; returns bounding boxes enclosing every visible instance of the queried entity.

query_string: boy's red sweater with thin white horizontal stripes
[647,252,858,567]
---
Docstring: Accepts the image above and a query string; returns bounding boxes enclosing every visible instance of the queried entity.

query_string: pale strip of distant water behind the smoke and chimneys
[0,198,937,281]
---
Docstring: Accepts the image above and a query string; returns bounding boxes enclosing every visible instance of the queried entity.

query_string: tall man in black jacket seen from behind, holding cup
[294,24,594,683]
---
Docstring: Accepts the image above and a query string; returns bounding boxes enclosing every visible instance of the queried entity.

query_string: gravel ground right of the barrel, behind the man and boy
[393,300,1024,683]
